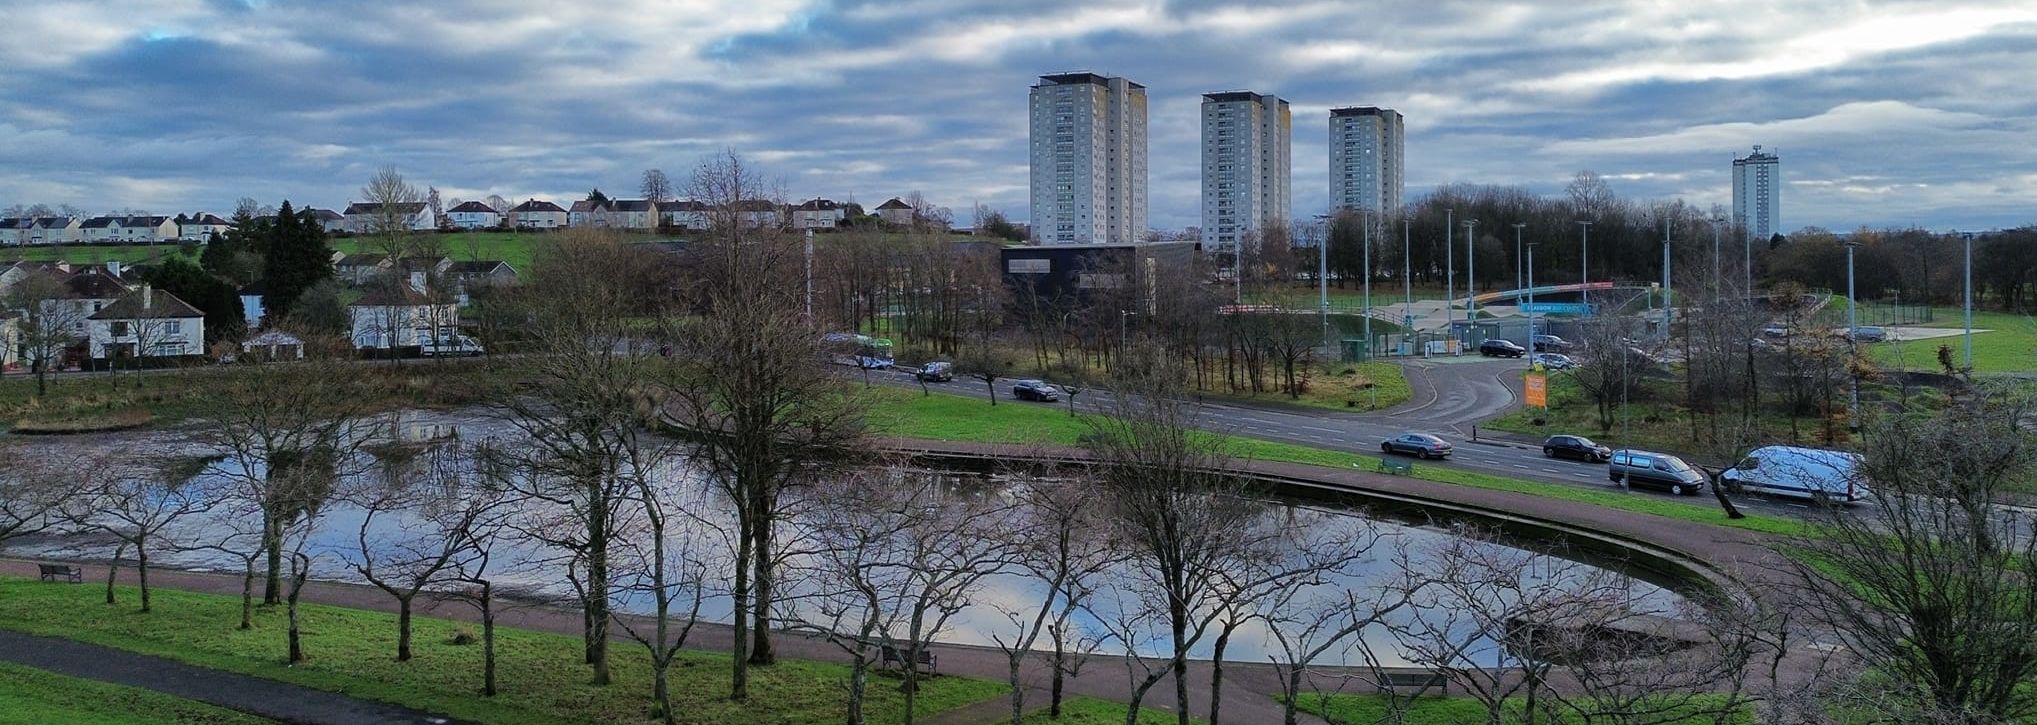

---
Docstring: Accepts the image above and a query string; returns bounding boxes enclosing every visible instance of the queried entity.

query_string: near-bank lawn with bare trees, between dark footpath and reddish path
[0,578,1006,723]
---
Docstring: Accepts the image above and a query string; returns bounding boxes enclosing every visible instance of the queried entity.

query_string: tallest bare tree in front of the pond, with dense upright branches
[664,153,866,701]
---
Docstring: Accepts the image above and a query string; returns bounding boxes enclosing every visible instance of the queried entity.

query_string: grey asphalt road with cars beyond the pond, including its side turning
[872,360,1809,515]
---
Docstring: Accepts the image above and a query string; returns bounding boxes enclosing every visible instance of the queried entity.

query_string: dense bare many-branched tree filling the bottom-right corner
[1788,389,2037,723]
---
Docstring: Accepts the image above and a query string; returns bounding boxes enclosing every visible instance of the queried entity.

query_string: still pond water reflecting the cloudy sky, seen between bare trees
[6,411,1687,666]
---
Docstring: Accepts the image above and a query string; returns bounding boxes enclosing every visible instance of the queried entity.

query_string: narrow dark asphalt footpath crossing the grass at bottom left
[0,629,456,725]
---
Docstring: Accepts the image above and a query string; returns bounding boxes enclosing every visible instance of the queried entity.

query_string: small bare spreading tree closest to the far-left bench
[63,456,224,611]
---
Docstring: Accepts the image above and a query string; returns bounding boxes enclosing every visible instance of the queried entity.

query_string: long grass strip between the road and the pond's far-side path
[870,387,1805,534]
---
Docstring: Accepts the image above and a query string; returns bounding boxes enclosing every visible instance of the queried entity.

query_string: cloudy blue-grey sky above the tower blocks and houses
[0,0,2037,228]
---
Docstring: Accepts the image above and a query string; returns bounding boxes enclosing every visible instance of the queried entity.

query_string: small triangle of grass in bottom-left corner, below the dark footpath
[0,662,273,725]
